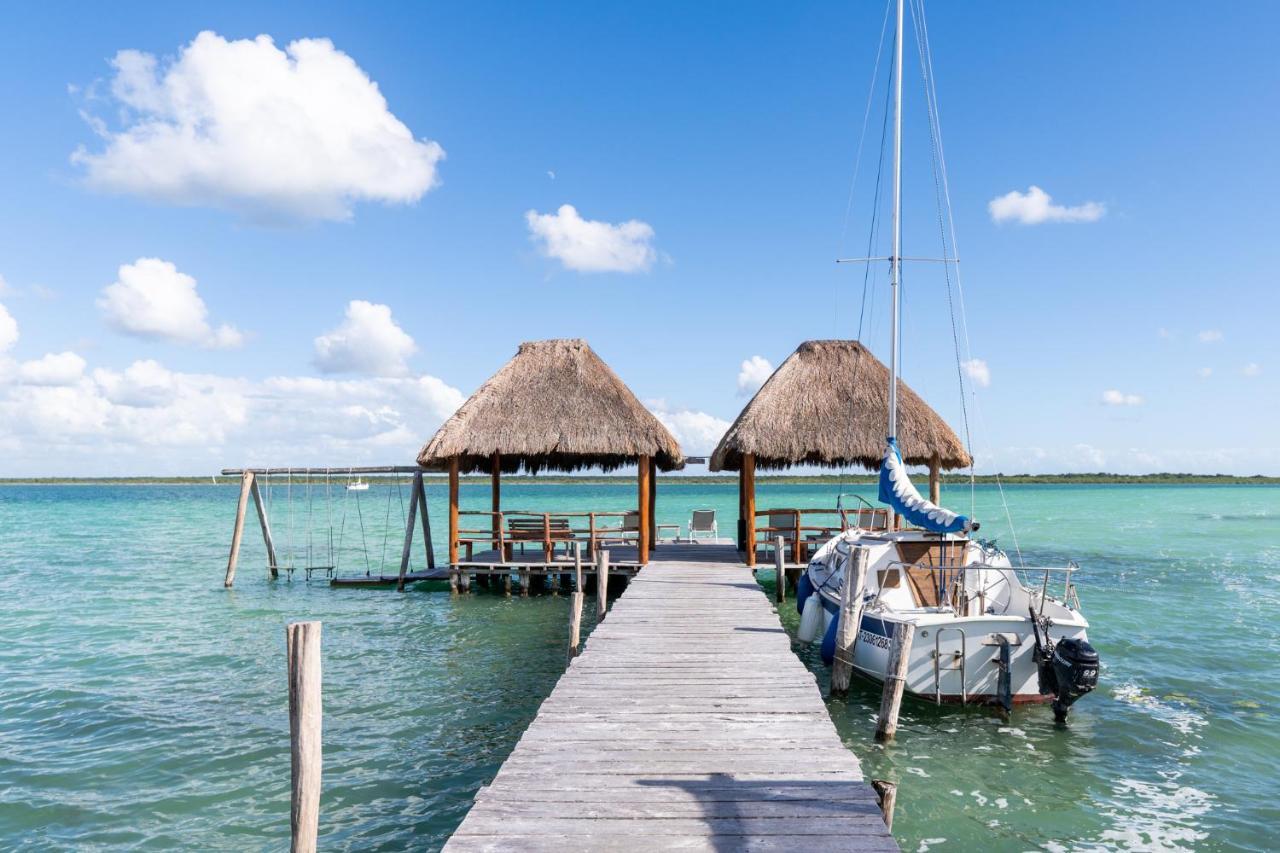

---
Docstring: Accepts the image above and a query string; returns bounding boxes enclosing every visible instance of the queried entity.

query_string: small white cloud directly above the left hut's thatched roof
[525,205,658,273]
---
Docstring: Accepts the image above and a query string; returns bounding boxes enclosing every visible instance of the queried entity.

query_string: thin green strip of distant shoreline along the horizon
[0,474,1280,487]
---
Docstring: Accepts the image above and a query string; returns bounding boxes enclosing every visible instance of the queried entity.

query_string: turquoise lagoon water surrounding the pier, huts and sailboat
[0,482,1280,850]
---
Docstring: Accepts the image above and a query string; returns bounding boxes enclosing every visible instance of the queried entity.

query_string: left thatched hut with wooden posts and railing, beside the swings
[417,339,684,565]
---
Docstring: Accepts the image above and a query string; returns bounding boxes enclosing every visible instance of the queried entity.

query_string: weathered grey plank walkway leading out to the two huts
[445,546,897,853]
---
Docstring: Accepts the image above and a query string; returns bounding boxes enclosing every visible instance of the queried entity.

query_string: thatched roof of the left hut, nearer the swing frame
[417,339,684,473]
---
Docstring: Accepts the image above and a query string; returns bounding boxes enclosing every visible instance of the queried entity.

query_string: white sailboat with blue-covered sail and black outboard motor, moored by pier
[796,0,1098,722]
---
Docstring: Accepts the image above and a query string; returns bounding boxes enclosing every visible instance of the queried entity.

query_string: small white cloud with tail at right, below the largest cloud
[97,257,244,347]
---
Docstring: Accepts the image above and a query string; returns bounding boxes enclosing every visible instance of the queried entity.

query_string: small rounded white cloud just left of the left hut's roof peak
[315,300,417,377]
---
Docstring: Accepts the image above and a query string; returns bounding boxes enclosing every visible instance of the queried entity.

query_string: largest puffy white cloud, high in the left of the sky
[72,32,444,219]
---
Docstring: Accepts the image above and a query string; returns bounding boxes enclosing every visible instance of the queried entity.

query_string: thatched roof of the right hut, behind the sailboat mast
[710,341,969,471]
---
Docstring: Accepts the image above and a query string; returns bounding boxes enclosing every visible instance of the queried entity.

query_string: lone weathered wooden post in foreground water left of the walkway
[284,622,321,853]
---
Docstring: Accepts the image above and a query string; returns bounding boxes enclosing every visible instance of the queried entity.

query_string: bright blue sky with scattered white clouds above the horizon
[0,3,1280,474]
